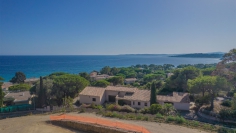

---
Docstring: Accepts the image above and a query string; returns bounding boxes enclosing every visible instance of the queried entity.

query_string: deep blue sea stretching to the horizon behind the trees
[0,55,220,81]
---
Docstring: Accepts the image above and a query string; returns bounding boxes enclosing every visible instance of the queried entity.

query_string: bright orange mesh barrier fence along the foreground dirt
[50,115,150,133]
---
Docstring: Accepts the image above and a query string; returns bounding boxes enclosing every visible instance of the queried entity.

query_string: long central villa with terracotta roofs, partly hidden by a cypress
[79,86,190,110]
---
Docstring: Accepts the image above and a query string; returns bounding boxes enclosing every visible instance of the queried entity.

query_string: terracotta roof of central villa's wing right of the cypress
[157,92,190,103]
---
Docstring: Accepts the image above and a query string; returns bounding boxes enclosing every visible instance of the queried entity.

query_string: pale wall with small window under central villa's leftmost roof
[79,95,102,105]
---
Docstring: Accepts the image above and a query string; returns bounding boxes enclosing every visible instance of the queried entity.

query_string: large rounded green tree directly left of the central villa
[52,74,89,105]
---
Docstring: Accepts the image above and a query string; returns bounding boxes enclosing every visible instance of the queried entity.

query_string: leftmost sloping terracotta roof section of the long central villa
[80,86,105,96]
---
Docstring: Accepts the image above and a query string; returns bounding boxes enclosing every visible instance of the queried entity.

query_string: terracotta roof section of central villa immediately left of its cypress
[122,89,150,101]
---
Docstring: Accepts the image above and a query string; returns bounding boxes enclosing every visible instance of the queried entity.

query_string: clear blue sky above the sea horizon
[0,0,236,55]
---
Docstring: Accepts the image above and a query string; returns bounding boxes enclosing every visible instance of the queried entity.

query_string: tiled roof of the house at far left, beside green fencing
[5,91,31,102]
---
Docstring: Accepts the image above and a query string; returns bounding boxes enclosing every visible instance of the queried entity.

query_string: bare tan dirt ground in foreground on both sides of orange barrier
[0,113,210,133]
